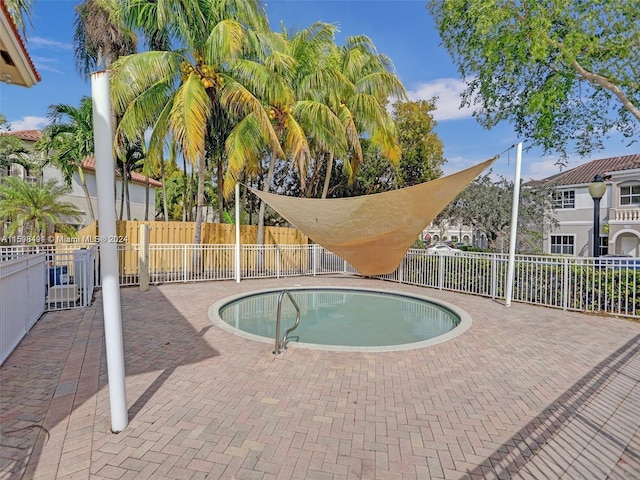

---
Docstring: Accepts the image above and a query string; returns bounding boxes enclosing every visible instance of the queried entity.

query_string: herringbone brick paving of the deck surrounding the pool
[0,276,640,480]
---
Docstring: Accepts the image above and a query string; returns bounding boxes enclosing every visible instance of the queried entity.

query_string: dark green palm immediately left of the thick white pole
[36,97,95,222]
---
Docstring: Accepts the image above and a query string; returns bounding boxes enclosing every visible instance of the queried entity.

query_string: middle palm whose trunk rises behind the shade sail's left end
[225,22,346,244]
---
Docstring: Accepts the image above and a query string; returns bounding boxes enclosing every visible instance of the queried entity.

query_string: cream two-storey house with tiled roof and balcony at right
[527,154,640,257]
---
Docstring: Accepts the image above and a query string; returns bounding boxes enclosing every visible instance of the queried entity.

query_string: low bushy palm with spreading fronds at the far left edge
[0,177,80,243]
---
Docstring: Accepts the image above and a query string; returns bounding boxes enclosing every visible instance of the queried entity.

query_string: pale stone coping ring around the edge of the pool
[208,285,472,353]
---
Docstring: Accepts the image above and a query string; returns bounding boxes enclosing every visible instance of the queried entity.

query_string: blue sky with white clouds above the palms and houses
[0,0,640,180]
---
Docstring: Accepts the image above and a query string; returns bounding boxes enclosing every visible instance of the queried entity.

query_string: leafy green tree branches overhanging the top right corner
[428,0,640,156]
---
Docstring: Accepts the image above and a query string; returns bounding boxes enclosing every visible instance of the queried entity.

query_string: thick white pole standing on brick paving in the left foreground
[91,72,129,433]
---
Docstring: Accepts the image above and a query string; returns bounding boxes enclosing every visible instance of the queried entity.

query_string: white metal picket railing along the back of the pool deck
[0,244,640,318]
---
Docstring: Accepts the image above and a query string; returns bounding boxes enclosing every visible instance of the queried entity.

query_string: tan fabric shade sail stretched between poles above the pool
[251,157,497,275]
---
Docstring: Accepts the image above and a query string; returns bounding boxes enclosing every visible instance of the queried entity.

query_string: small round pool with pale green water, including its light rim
[209,287,471,351]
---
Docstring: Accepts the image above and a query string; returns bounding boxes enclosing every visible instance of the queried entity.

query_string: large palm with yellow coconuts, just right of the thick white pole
[112,0,284,243]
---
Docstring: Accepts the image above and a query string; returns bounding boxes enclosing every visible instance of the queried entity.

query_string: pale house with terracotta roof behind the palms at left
[0,130,162,228]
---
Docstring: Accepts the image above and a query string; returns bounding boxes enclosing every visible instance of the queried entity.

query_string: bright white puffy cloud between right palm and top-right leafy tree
[407,78,473,121]
